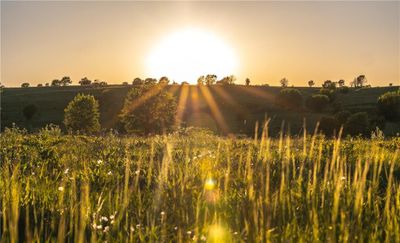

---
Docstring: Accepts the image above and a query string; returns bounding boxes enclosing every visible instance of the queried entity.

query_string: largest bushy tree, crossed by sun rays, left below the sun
[120,85,177,135]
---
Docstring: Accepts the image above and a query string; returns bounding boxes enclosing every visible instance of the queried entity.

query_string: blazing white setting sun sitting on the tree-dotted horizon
[146,28,238,83]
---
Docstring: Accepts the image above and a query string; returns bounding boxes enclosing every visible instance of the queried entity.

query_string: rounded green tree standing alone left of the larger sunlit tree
[64,94,100,134]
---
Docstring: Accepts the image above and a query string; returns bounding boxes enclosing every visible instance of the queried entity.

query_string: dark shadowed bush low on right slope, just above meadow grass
[344,112,370,136]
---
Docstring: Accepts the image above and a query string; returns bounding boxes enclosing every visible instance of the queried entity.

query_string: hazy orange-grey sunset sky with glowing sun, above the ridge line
[1,1,400,86]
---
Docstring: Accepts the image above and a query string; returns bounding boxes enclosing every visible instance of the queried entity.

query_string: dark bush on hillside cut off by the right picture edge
[378,90,400,121]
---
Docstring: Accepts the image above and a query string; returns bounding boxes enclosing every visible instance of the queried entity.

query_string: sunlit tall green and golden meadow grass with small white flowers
[0,127,400,242]
